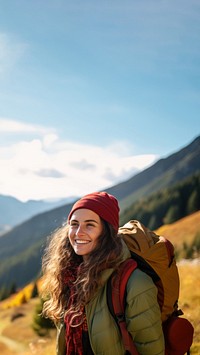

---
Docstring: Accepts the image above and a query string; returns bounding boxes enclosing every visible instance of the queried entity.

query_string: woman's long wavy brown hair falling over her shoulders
[42,220,122,322]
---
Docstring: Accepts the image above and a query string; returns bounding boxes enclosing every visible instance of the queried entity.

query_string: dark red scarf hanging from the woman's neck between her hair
[65,266,87,355]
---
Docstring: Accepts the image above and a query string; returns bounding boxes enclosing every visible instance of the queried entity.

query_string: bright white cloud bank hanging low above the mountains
[0,121,158,201]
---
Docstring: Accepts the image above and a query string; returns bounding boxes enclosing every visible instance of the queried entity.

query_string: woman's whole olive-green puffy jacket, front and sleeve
[57,244,164,355]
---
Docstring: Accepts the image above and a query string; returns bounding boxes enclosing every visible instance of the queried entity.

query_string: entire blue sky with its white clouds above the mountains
[0,0,200,201]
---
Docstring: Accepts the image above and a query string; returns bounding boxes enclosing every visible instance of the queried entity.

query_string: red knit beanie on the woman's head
[68,192,119,231]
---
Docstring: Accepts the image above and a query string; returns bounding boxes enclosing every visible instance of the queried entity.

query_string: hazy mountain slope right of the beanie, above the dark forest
[106,136,200,209]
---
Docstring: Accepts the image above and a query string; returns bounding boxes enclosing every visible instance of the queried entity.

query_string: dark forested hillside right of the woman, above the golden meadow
[120,170,200,230]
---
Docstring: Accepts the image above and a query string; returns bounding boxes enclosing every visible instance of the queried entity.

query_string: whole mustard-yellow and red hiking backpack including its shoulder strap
[107,220,194,355]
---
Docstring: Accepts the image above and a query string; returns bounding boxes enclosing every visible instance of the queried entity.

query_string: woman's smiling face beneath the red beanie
[68,208,103,260]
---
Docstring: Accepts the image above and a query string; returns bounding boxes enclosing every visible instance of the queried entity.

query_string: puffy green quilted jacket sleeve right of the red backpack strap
[125,269,164,355]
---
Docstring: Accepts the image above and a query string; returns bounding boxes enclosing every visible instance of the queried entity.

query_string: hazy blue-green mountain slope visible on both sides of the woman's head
[0,137,200,286]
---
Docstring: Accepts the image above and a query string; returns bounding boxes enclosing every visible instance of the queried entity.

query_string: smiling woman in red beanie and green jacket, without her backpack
[43,192,164,355]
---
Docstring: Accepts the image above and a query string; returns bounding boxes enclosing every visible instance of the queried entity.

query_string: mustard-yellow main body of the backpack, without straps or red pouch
[118,220,180,322]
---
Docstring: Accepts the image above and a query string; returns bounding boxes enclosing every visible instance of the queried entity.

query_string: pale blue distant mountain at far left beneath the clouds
[0,195,75,234]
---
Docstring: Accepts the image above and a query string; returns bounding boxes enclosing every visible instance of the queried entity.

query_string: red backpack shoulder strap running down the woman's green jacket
[111,259,138,355]
